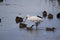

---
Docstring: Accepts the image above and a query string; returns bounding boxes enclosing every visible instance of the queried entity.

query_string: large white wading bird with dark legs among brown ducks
[26,15,43,29]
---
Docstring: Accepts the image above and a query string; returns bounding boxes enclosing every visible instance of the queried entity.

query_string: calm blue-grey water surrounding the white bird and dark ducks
[0,0,60,40]
